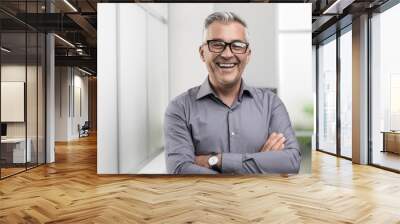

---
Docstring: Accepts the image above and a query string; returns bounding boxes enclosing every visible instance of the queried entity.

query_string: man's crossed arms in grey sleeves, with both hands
[164,97,301,174]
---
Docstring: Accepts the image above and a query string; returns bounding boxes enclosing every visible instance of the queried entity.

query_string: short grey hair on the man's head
[203,12,249,42]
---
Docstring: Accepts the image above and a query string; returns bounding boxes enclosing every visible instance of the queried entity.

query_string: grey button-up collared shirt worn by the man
[164,78,301,174]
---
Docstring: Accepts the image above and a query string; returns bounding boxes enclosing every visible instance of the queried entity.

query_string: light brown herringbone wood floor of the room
[0,134,400,224]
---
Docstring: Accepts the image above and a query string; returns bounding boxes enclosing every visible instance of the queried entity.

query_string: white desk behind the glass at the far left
[1,138,32,163]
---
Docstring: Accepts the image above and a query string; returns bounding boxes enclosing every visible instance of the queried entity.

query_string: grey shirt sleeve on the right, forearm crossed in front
[222,95,301,174]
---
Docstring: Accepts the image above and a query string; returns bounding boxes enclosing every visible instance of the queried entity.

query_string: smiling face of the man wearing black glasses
[200,22,251,88]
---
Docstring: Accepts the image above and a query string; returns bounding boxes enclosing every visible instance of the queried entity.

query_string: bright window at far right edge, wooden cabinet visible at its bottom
[370,4,400,170]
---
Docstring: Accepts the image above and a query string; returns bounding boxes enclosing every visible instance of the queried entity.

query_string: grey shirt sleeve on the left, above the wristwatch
[164,98,218,174]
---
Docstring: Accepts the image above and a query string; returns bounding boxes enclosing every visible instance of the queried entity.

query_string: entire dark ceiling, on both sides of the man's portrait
[0,0,394,73]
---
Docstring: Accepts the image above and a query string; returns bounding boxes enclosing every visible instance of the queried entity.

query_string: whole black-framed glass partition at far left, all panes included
[0,1,46,179]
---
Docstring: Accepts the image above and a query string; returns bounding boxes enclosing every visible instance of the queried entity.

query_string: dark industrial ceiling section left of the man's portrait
[0,0,100,74]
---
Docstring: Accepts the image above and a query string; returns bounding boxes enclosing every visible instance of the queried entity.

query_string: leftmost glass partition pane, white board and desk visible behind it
[0,32,30,177]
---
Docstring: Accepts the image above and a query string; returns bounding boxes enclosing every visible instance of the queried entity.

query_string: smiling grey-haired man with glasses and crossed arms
[164,12,301,174]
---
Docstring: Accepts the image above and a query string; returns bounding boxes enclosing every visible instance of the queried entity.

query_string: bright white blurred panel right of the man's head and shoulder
[276,3,314,129]
